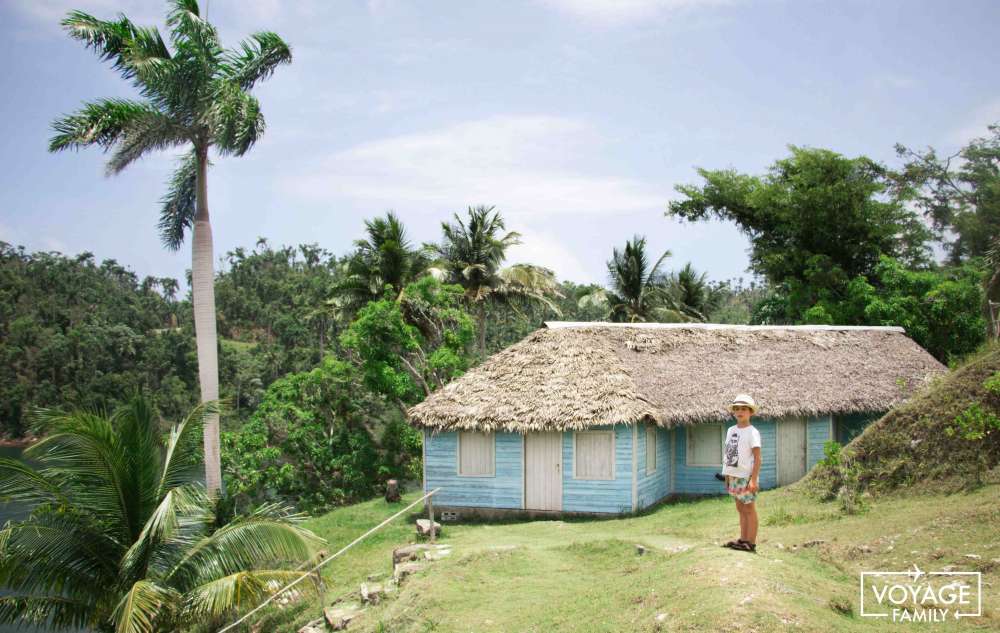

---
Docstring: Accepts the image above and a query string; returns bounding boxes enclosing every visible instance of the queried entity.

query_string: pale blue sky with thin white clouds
[0,0,1000,283]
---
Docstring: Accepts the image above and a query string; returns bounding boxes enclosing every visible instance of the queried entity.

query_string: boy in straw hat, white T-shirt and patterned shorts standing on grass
[722,394,760,552]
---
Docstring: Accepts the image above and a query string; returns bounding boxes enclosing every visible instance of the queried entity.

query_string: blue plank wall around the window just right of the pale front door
[563,424,632,512]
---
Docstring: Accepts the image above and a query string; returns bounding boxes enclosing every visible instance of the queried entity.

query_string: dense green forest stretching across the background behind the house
[0,128,998,509]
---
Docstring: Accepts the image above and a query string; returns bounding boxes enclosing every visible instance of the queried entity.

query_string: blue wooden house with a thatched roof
[408,322,946,514]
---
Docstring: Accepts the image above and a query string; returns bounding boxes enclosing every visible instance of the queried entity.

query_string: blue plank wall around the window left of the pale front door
[424,431,524,509]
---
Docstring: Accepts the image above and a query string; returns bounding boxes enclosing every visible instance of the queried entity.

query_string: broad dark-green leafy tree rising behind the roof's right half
[667,146,930,323]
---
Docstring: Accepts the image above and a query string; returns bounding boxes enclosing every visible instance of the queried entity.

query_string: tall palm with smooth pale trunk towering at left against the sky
[49,0,292,494]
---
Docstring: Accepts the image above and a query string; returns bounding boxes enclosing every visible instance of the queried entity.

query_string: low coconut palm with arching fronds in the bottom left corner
[0,396,318,632]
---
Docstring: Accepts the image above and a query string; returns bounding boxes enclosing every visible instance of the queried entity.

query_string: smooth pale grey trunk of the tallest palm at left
[191,148,222,495]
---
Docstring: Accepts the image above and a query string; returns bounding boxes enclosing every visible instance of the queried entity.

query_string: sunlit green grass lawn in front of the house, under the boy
[259,484,1000,633]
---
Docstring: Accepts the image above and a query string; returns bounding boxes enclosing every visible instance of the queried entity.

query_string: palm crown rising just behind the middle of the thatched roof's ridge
[579,235,694,323]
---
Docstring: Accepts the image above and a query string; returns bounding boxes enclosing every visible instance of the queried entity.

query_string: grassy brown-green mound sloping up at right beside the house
[801,344,1000,498]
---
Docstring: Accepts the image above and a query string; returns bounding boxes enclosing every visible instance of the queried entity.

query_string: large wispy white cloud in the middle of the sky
[281,116,668,217]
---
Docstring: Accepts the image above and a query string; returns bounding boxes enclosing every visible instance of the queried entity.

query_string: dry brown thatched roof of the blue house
[408,321,947,432]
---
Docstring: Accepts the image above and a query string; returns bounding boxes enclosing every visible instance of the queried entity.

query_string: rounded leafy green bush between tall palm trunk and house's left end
[222,356,392,511]
